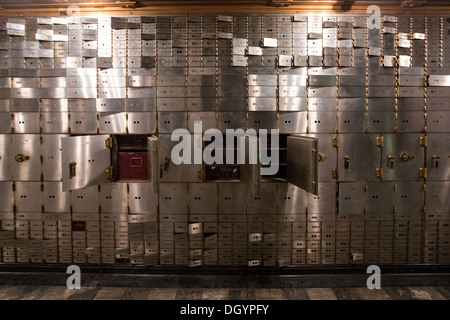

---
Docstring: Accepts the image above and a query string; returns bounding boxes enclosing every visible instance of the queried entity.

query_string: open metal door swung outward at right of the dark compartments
[286,135,318,194]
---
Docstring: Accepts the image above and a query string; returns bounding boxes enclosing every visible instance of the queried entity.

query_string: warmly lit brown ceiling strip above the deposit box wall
[0,0,450,16]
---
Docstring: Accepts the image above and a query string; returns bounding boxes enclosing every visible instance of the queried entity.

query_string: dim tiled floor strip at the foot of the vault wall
[0,286,450,300]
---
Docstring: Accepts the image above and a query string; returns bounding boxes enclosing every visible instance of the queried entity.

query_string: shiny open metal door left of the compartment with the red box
[61,135,112,191]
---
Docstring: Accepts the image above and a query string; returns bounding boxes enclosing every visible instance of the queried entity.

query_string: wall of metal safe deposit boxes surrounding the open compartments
[0,15,450,266]
